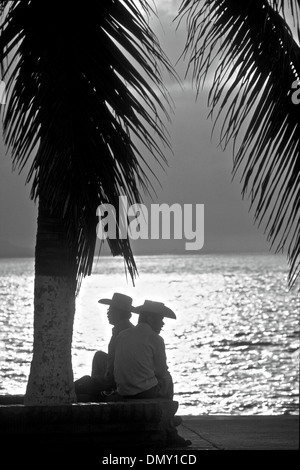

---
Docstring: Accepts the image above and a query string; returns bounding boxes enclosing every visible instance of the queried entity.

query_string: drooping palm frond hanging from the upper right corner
[178,0,300,286]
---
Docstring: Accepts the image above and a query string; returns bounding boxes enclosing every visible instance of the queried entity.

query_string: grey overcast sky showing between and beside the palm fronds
[0,0,269,253]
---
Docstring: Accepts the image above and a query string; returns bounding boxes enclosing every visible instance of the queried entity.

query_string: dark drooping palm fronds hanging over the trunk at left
[0,0,173,288]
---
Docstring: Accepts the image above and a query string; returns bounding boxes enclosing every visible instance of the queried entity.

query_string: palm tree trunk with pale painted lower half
[24,198,76,405]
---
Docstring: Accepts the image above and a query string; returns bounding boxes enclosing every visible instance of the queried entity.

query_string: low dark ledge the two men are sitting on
[0,399,178,450]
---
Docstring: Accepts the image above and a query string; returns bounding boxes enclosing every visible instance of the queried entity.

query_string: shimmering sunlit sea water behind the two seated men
[0,254,300,415]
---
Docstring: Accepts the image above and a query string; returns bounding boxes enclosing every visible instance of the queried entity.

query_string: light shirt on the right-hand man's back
[114,323,168,396]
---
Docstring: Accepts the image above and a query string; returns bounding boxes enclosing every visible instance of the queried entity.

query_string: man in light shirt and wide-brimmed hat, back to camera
[114,300,191,447]
